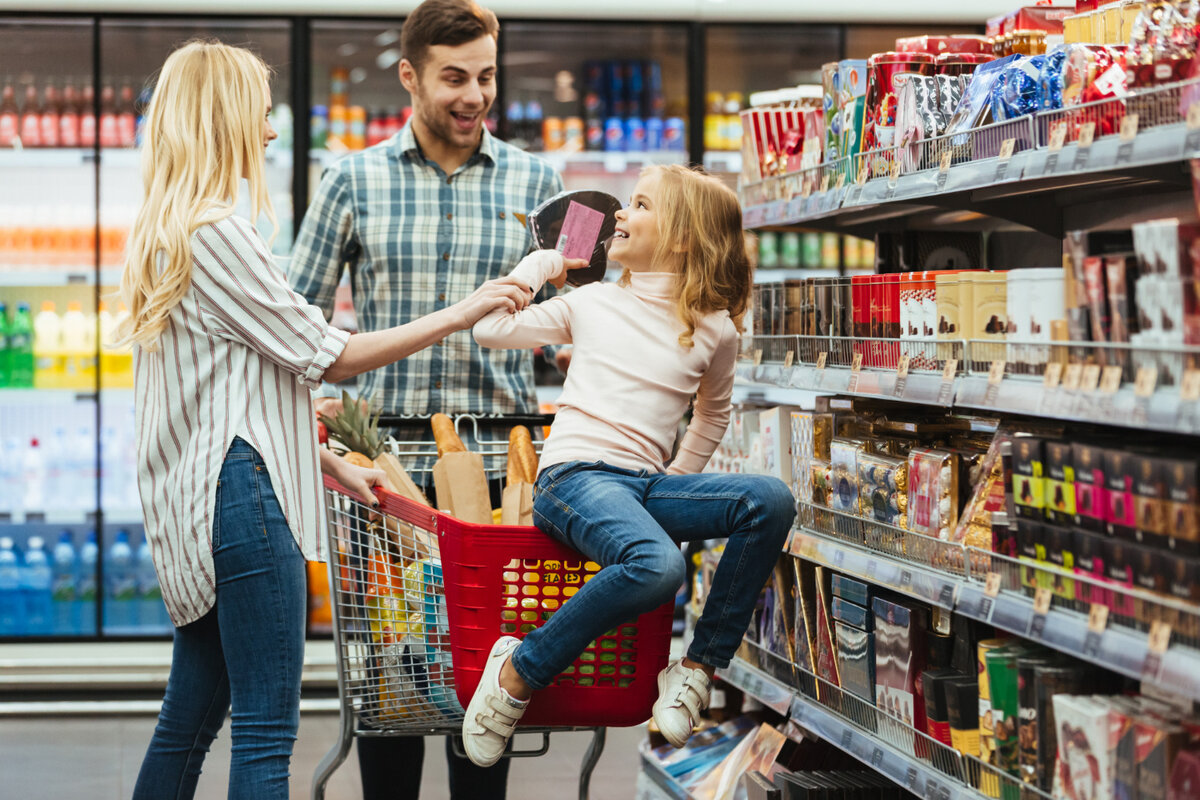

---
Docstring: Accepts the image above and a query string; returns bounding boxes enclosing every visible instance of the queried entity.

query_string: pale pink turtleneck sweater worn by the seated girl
[474,251,738,475]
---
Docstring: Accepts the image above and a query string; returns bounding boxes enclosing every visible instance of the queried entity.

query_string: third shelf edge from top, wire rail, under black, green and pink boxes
[790,513,1200,700]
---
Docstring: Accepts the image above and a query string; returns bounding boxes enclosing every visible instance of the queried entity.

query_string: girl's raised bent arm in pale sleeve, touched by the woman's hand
[473,249,571,350]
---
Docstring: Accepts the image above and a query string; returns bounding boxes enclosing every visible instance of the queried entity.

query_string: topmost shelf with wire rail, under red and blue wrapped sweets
[742,82,1200,236]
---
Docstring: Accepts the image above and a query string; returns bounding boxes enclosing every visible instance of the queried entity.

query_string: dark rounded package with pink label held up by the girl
[527,190,624,286]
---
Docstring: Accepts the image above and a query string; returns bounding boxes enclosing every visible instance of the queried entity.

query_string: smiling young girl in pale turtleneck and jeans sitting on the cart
[462,167,796,766]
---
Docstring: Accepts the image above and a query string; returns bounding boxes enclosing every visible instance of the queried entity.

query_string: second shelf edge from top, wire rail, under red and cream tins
[737,336,1200,434]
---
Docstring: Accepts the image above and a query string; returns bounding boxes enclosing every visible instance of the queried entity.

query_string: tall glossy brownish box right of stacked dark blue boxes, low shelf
[871,597,926,730]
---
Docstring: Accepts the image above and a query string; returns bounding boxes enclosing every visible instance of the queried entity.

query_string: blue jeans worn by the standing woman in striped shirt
[133,438,307,800]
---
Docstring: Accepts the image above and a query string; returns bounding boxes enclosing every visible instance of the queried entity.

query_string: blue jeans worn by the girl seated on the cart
[512,462,796,690]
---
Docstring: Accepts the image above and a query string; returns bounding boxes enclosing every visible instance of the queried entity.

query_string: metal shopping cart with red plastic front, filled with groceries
[312,416,673,800]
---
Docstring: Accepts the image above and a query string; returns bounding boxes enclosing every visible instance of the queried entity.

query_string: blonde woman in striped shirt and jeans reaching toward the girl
[121,42,532,800]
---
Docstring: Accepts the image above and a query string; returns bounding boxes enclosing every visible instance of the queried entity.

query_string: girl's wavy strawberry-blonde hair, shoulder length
[620,164,754,348]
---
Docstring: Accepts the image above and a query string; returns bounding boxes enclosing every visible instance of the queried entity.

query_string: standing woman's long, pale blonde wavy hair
[118,41,276,350]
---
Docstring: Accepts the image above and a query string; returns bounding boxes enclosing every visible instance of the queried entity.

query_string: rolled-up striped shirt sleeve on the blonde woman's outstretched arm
[192,217,350,389]
